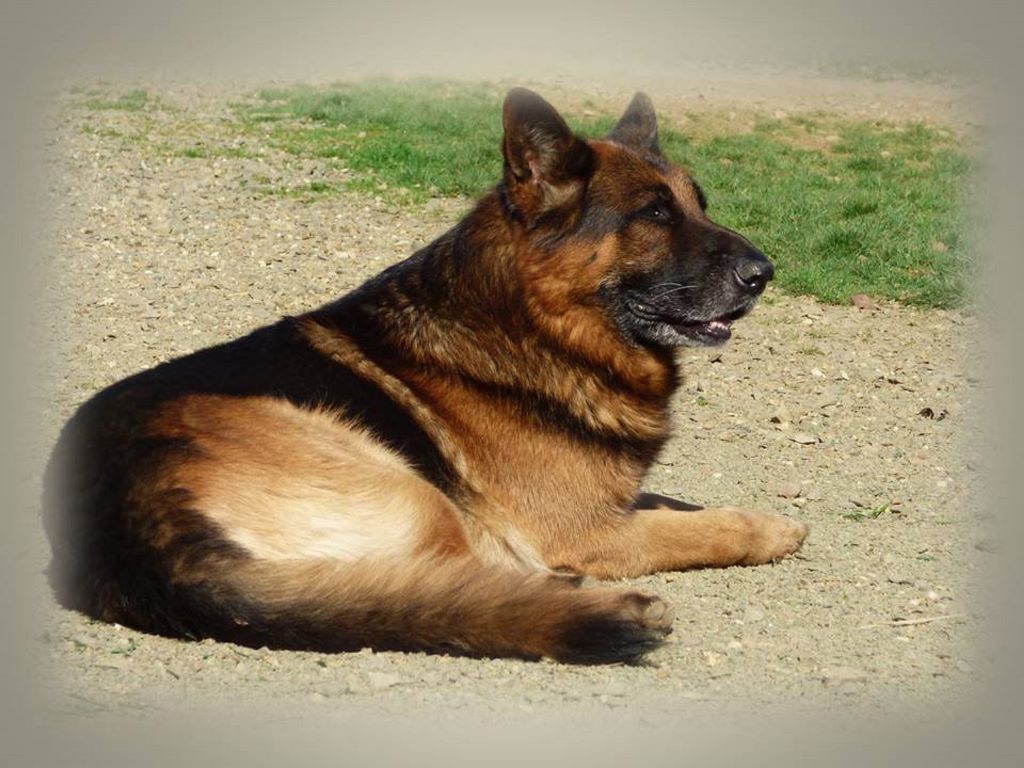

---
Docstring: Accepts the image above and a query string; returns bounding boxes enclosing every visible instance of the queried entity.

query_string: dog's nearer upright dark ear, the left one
[502,88,593,219]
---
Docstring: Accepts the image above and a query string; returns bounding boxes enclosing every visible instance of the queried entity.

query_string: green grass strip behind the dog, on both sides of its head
[234,81,972,307]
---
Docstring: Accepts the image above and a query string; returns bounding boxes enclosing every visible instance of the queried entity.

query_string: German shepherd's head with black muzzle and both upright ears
[501,88,773,348]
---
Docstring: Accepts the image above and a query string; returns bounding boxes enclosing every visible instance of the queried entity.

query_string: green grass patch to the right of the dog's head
[663,119,971,307]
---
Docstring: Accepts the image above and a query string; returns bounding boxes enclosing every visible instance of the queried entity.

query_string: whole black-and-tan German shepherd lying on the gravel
[44,89,807,664]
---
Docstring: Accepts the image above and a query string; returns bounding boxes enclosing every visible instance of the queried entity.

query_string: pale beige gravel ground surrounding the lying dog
[36,75,993,721]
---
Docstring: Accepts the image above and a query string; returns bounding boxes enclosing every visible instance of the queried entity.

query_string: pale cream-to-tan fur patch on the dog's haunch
[168,398,439,560]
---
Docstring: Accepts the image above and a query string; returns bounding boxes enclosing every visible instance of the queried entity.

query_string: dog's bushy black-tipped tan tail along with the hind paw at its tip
[205,557,672,664]
